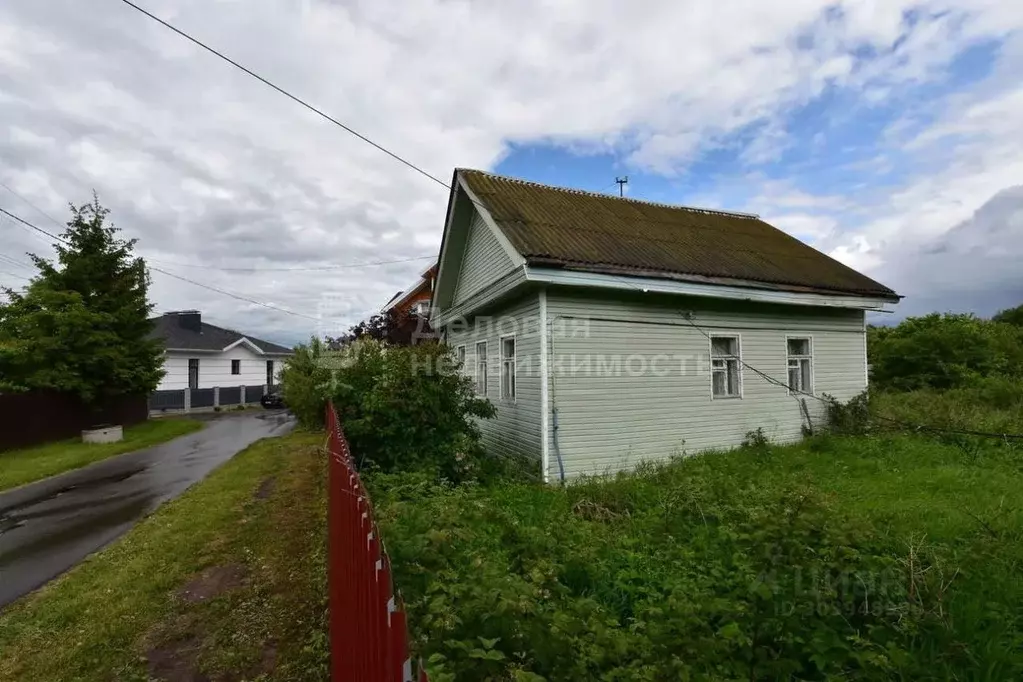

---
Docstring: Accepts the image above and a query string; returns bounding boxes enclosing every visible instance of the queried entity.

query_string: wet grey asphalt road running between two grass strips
[0,412,294,607]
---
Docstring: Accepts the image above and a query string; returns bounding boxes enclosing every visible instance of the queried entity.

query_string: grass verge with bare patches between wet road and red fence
[0,433,328,682]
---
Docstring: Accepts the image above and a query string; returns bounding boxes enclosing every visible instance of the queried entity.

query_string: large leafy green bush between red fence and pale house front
[281,338,494,481]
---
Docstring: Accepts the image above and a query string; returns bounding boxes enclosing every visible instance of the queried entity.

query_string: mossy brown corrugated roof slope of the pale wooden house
[458,169,897,299]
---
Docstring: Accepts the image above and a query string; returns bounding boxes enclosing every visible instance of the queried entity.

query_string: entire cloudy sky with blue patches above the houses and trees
[0,0,1023,342]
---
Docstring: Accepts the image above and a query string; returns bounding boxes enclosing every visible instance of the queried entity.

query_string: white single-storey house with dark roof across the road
[150,310,292,391]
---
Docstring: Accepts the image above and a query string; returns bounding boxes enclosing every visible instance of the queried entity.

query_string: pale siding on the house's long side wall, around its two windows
[547,290,865,480]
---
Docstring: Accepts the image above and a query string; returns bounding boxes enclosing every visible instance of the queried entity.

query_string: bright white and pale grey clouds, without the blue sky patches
[0,0,1023,338]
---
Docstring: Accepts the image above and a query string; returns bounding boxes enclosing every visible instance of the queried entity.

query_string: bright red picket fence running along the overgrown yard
[326,405,429,682]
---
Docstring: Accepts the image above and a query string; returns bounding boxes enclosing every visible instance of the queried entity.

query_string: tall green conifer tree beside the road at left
[0,196,164,406]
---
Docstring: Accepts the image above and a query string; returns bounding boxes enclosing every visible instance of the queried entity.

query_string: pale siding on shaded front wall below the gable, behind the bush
[446,292,541,459]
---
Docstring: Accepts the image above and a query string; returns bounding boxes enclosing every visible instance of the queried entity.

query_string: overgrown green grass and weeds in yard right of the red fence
[370,435,1023,682]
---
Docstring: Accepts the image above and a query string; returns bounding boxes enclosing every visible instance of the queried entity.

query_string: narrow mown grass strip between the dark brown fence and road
[0,418,203,491]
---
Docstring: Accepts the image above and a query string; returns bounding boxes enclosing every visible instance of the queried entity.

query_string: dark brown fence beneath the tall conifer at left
[0,391,149,453]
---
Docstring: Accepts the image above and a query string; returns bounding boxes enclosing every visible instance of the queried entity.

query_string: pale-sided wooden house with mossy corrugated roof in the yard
[431,170,899,480]
